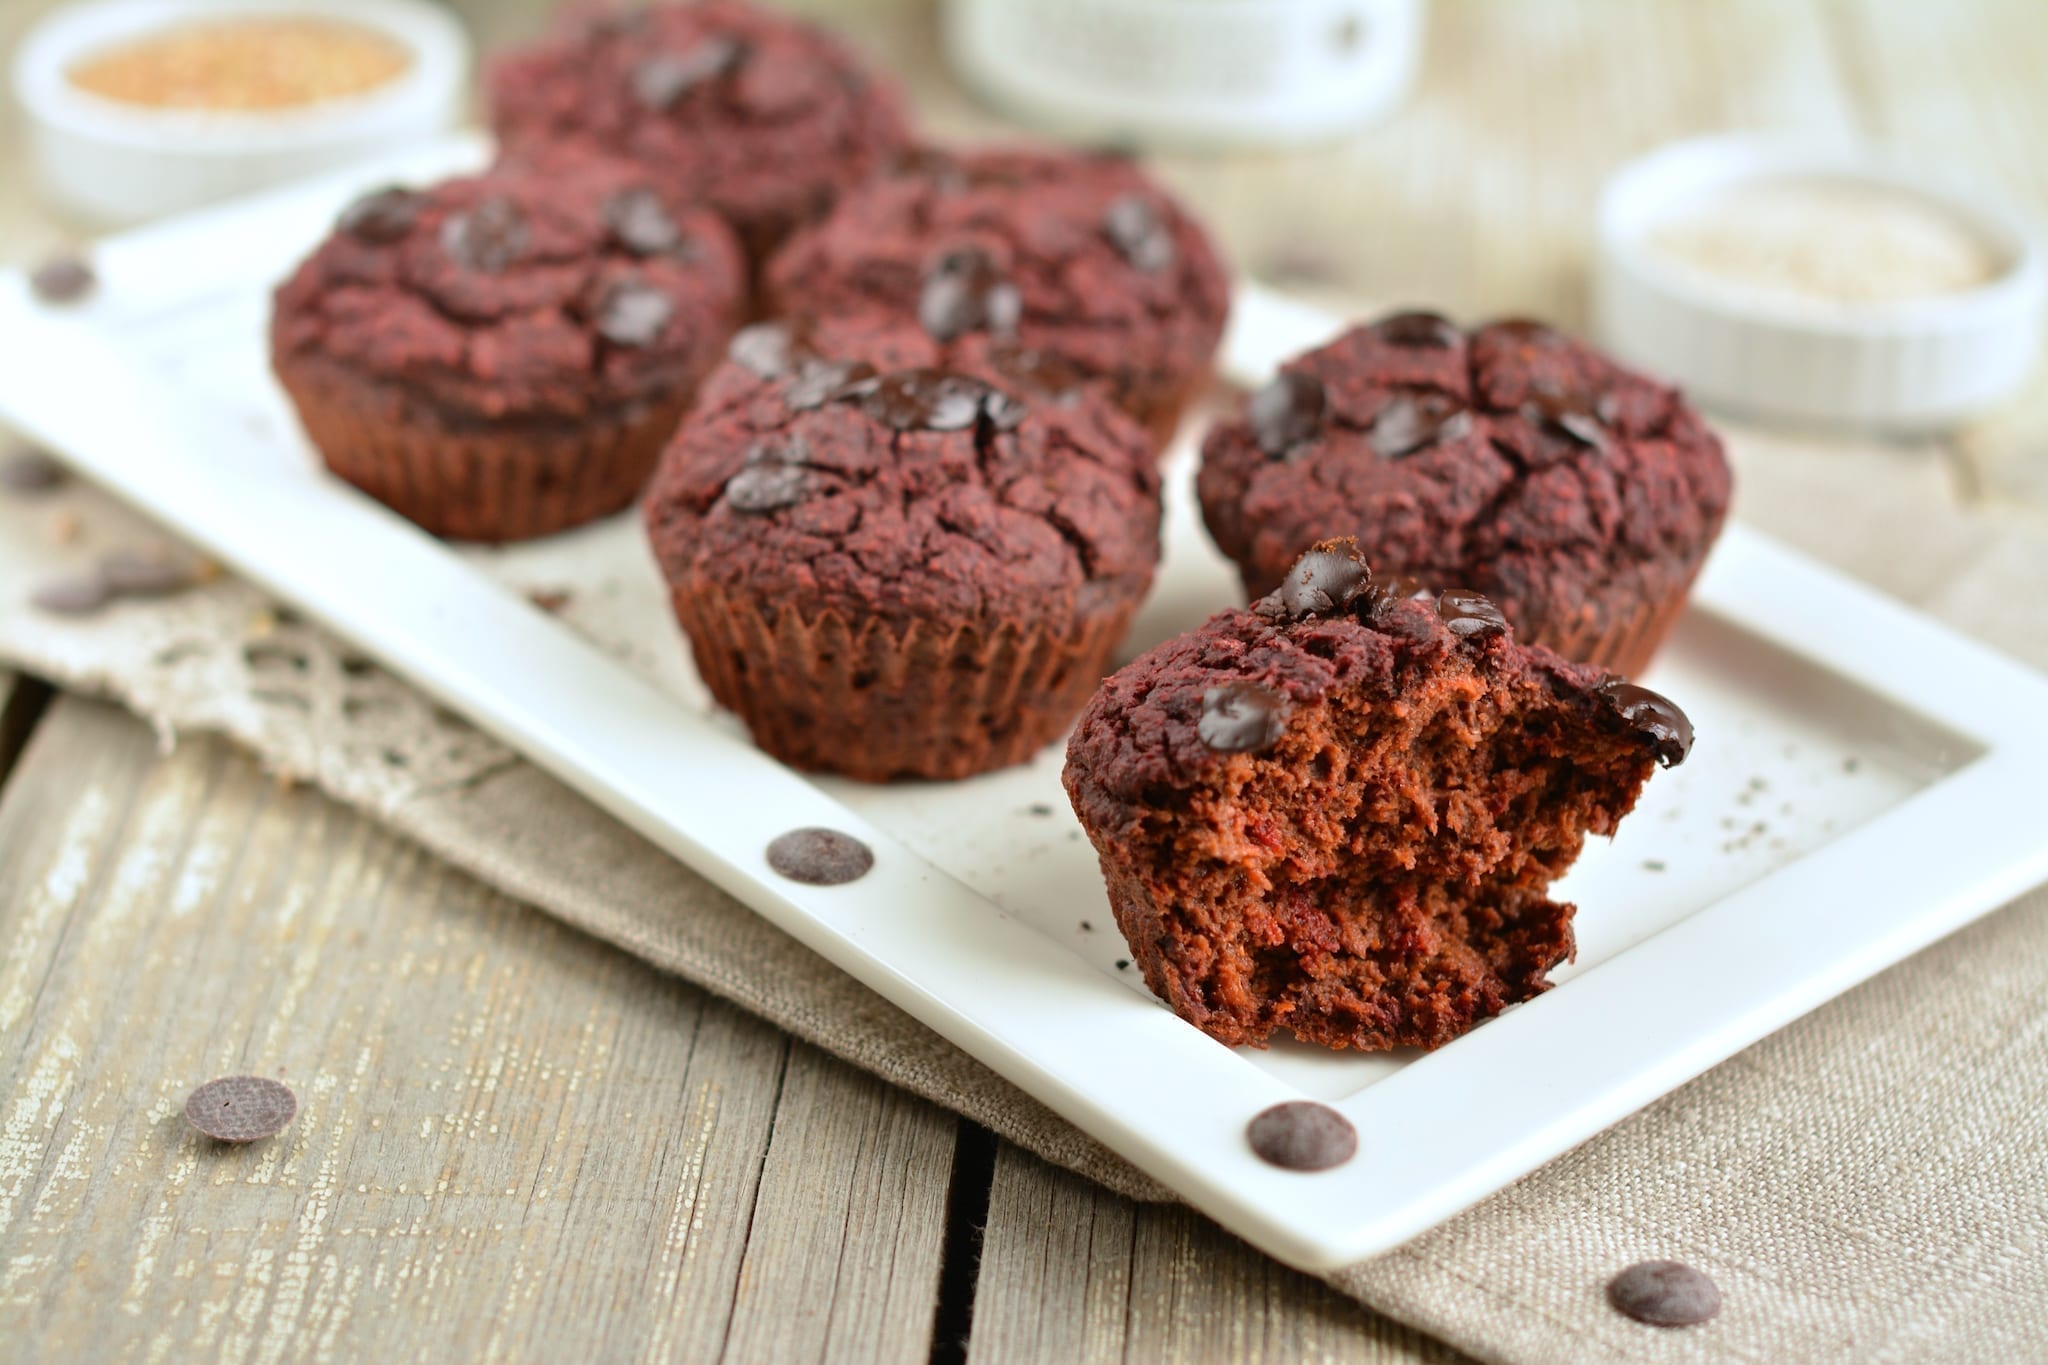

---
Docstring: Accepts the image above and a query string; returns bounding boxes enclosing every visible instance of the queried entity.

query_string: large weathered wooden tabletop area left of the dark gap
[0,698,950,1361]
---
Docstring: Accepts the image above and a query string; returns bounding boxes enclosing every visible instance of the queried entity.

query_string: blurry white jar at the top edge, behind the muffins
[942,0,1421,145]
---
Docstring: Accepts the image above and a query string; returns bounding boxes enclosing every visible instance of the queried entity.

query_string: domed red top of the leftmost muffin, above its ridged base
[270,158,745,420]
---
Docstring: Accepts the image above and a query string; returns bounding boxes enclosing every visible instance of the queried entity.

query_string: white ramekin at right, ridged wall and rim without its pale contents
[1593,135,2048,432]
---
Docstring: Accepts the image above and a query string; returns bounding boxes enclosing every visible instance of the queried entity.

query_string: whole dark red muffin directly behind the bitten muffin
[1196,313,1729,673]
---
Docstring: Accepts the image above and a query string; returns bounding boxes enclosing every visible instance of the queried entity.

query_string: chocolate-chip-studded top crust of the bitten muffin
[1067,540,1692,829]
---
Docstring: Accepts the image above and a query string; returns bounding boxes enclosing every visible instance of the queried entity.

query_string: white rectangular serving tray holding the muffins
[12,139,2048,1269]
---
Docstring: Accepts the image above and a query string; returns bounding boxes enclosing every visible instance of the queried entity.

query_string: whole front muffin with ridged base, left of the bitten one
[647,319,1159,782]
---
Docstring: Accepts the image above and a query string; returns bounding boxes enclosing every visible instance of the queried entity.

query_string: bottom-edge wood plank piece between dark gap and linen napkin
[969,1144,1464,1365]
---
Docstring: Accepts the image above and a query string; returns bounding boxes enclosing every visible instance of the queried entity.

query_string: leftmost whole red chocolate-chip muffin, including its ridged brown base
[270,160,745,540]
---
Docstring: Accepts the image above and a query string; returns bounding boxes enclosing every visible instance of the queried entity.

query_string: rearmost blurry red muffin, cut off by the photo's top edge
[489,0,909,258]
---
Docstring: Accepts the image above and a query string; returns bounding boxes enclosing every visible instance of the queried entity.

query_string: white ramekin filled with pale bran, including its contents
[1593,137,2048,432]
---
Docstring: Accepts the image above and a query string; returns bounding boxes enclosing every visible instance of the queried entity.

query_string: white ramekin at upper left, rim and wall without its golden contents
[14,0,469,225]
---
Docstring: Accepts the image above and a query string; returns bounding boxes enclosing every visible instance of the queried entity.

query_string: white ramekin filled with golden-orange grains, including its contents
[14,0,469,225]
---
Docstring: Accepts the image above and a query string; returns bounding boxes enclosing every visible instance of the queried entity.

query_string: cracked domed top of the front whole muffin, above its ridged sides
[647,317,1159,628]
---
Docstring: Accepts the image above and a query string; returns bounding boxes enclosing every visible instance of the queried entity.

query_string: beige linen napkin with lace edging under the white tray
[0,421,2048,1361]
